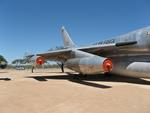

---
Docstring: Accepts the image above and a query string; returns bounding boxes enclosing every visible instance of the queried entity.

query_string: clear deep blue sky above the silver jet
[0,0,150,62]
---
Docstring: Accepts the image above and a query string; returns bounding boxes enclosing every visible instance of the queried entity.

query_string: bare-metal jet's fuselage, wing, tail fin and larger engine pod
[37,27,150,78]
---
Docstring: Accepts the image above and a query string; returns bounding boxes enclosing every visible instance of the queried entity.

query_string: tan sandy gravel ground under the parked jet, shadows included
[0,69,150,113]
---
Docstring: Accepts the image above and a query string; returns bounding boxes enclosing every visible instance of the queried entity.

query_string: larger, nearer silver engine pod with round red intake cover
[65,56,113,74]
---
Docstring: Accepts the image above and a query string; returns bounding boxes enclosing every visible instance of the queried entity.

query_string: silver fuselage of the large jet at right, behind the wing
[97,27,150,78]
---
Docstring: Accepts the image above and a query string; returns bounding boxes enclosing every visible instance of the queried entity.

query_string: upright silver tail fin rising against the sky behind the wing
[61,26,76,48]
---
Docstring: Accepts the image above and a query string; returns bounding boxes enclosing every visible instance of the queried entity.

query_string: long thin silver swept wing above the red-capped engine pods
[37,41,137,61]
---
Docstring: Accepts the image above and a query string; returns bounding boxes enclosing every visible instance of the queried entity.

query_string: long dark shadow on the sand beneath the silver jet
[27,73,150,89]
